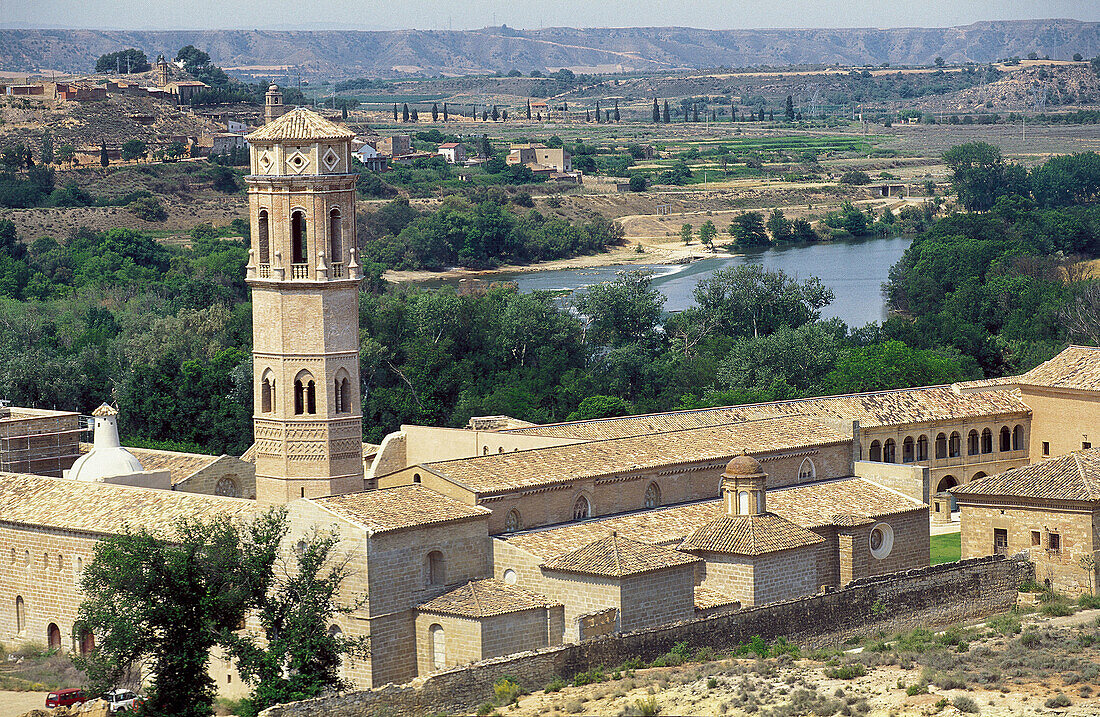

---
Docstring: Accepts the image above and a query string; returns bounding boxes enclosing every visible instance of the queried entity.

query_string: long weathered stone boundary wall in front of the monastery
[261,555,1034,717]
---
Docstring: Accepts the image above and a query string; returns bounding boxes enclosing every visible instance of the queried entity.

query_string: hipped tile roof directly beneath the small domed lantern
[680,512,825,555]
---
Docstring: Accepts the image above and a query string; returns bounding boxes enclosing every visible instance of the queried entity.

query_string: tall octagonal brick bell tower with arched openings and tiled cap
[245,108,363,505]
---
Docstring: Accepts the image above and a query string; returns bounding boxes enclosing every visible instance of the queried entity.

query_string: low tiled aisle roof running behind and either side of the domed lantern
[497,477,927,560]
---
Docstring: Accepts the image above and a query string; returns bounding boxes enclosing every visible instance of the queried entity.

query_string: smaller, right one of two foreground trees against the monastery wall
[221,523,366,714]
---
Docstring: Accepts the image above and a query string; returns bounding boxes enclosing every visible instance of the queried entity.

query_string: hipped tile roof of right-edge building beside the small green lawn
[952,449,1100,503]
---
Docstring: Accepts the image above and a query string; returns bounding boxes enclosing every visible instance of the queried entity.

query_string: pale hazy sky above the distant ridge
[0,0,1100,30]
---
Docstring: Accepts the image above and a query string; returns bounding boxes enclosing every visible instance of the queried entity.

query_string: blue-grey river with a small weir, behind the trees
[433,236,911,328]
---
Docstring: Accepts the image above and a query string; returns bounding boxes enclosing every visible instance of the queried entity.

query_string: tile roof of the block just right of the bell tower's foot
[307,485,492,534]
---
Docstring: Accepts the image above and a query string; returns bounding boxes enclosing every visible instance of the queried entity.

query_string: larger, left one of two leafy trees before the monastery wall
[74,511,285,717]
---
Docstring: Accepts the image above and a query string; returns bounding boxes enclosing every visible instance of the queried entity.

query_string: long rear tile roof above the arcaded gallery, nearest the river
[507,386,1030,440]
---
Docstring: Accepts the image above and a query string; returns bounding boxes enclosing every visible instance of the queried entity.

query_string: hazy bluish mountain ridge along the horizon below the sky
[0,20,1100,77]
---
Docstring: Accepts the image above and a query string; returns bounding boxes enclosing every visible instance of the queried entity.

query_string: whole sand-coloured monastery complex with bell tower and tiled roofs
[0,103,1100,696]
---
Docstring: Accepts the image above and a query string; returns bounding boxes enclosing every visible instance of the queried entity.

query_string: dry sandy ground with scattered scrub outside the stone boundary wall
[499,610,1100,717]
